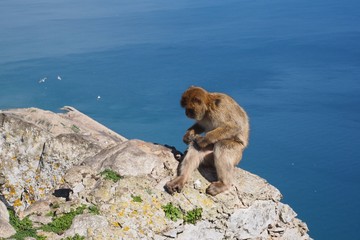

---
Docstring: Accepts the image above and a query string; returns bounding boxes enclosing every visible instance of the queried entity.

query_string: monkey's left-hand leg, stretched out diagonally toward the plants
[165,144,212,194]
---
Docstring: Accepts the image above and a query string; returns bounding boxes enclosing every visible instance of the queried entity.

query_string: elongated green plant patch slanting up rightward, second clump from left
[41,205,87,234]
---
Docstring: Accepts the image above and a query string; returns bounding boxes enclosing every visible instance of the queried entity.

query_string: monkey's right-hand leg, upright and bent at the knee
[206,140,244,196]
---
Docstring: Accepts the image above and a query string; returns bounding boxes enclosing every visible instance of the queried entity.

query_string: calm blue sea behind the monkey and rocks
[0,0,360,240]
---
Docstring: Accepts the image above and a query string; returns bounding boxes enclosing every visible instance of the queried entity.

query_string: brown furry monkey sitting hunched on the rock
[165,86,250,196]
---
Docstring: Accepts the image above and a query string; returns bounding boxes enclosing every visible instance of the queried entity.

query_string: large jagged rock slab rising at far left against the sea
[0,107,126,212]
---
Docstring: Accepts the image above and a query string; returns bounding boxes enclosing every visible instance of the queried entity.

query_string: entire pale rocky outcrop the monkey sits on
[0,107,310,240]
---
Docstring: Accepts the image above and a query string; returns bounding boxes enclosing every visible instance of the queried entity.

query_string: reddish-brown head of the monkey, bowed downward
[180,87,208,121]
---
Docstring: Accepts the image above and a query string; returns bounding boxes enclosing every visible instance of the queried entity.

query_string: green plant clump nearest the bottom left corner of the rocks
[9,209,46,240]
